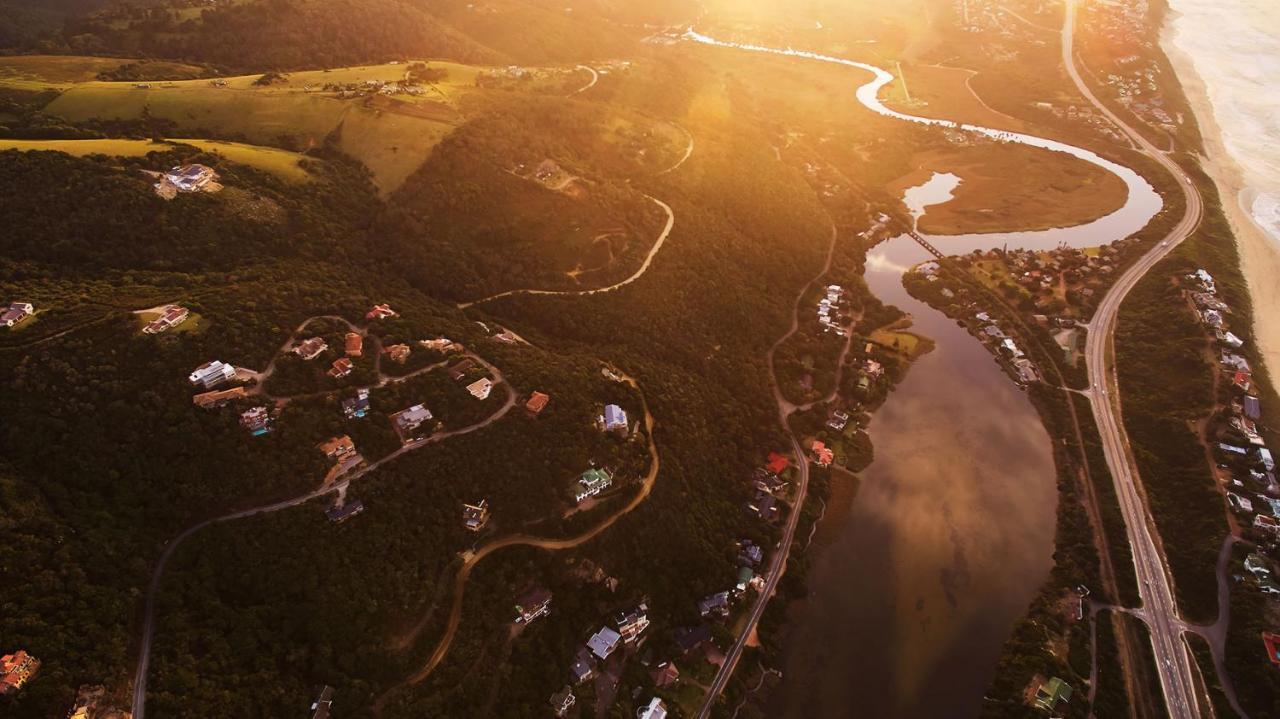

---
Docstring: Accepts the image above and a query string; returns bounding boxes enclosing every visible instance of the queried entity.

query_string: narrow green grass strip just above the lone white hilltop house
[0,138,310,182]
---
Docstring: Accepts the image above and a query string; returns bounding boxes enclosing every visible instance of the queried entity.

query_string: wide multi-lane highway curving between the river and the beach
[1062,0,1203,719]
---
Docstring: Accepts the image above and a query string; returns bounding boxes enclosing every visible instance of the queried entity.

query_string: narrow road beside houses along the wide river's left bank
[698,221,836,719]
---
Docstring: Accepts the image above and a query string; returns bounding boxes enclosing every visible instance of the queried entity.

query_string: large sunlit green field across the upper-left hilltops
[0,56,556,194]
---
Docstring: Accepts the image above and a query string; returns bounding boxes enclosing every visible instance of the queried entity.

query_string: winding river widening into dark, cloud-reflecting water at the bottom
[686,31,1161,719]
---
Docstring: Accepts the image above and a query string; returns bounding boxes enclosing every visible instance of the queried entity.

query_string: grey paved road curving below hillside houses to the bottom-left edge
[131,332,516,719]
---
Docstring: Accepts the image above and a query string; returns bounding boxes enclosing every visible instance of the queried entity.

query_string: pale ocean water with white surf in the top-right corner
[1169,0,1280,246]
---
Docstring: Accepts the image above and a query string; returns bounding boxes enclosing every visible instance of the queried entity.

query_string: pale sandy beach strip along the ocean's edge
[1160,8,1280,376]
